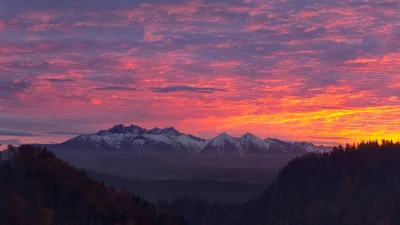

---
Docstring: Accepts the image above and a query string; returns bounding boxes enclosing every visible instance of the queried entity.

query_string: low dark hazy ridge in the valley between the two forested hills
[86,171,268,203]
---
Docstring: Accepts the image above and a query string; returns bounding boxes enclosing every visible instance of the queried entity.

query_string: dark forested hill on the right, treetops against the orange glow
[161,141,400,225]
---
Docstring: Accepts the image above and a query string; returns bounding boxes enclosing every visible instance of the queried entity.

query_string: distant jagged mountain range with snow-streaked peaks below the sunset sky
[58,124,331,156]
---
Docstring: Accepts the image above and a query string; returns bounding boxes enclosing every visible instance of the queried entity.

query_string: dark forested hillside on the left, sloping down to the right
[0,145,183,225]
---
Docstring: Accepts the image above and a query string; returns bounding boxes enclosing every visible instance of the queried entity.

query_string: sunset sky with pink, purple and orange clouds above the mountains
[0,0,400,144]
